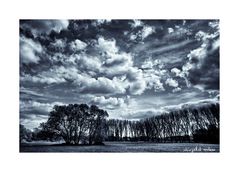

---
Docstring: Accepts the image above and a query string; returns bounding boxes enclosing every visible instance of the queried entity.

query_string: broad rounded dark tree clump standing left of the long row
[42,104,108,144]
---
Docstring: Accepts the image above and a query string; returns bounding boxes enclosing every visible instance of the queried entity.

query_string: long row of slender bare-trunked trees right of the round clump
[106,104,219,142]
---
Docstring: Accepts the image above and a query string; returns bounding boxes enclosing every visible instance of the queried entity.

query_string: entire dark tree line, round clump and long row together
[20,104,219,145]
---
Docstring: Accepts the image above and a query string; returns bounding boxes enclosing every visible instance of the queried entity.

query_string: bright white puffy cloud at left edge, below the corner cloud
[20,36,43,64]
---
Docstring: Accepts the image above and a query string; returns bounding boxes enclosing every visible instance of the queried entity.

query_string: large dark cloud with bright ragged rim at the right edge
[183,22,219,89]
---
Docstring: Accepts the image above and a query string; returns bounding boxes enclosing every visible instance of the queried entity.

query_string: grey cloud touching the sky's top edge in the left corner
[20,20,69,36]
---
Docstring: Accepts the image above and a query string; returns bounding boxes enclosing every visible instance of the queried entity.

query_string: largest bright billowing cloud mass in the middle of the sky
[20,34,146,95]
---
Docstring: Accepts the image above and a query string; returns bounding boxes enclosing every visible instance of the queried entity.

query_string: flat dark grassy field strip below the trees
[20,142,219,152]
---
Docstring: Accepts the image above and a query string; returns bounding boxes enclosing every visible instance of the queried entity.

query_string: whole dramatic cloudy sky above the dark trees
[19,20,219,128]
